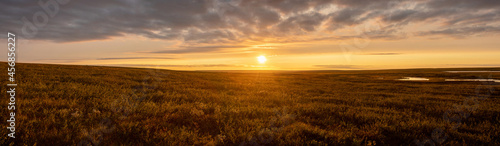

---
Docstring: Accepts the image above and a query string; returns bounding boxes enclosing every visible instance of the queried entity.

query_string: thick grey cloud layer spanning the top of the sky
[0,0,500,44]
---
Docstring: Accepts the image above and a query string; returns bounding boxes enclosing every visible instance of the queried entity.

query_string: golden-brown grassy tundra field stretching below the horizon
[0,62,500,145]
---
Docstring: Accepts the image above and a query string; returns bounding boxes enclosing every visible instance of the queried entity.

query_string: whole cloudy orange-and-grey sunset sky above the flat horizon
[0,0,500,70]
